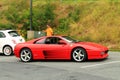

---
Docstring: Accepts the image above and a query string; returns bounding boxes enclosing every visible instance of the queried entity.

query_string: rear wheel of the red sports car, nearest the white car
[20,48,32,62]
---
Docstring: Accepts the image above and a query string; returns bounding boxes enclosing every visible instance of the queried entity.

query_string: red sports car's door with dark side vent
[42,37,70,59]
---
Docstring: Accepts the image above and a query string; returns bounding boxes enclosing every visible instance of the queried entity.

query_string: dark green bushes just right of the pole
[33,3,55,30]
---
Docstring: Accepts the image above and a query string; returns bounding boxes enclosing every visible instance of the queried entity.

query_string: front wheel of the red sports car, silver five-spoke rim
[72,48,87,62]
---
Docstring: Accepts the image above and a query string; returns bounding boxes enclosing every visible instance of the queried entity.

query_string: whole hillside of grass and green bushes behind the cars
[0,0,120,49]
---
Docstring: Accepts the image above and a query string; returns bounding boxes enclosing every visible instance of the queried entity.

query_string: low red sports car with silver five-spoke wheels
[14,36,108,62]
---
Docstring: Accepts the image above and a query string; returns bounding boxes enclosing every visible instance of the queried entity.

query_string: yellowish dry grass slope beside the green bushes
[0,0,120,49]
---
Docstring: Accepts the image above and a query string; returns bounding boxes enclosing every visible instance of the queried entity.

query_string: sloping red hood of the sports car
[75,42,108,50]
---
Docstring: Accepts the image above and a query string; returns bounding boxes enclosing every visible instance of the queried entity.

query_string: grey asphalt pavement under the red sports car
[0,52,120,80]
